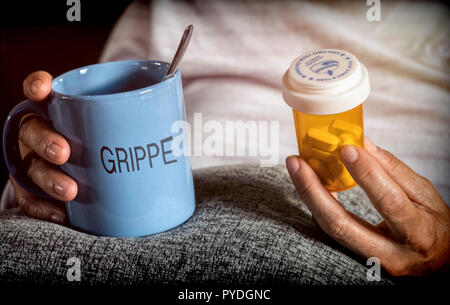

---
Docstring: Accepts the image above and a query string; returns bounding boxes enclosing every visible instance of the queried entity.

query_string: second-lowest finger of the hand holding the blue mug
[28,154,78,201]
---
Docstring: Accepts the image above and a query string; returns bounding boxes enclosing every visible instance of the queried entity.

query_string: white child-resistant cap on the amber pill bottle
[283,49,370,114]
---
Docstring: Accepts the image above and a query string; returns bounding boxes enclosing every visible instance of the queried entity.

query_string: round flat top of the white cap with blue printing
[295,49,357,86]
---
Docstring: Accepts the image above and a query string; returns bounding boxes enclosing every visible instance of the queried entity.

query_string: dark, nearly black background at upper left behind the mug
[0,0,131,188]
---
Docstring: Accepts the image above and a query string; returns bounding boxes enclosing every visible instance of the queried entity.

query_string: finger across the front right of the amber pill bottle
[341,145,419,240]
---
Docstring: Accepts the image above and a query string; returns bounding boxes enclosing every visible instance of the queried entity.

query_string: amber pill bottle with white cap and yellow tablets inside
[283,49,370,192]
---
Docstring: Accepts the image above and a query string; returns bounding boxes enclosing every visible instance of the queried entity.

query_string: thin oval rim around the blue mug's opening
[51,59,180,101]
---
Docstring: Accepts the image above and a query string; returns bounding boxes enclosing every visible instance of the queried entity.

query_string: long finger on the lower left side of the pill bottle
[286,156,394,257]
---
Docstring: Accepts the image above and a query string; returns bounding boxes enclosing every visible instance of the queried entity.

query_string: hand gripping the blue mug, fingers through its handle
[10,71,78,224]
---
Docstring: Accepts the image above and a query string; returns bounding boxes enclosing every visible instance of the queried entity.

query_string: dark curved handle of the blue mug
[3,100,55,201]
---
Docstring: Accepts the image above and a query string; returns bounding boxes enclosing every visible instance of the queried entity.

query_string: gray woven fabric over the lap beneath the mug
[0,165,392,285]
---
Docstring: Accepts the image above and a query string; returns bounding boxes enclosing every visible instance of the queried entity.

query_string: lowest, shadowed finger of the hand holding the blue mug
[10,176,68,224]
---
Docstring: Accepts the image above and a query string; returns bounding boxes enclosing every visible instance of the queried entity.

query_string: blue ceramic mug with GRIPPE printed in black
[3,60,195,237]
